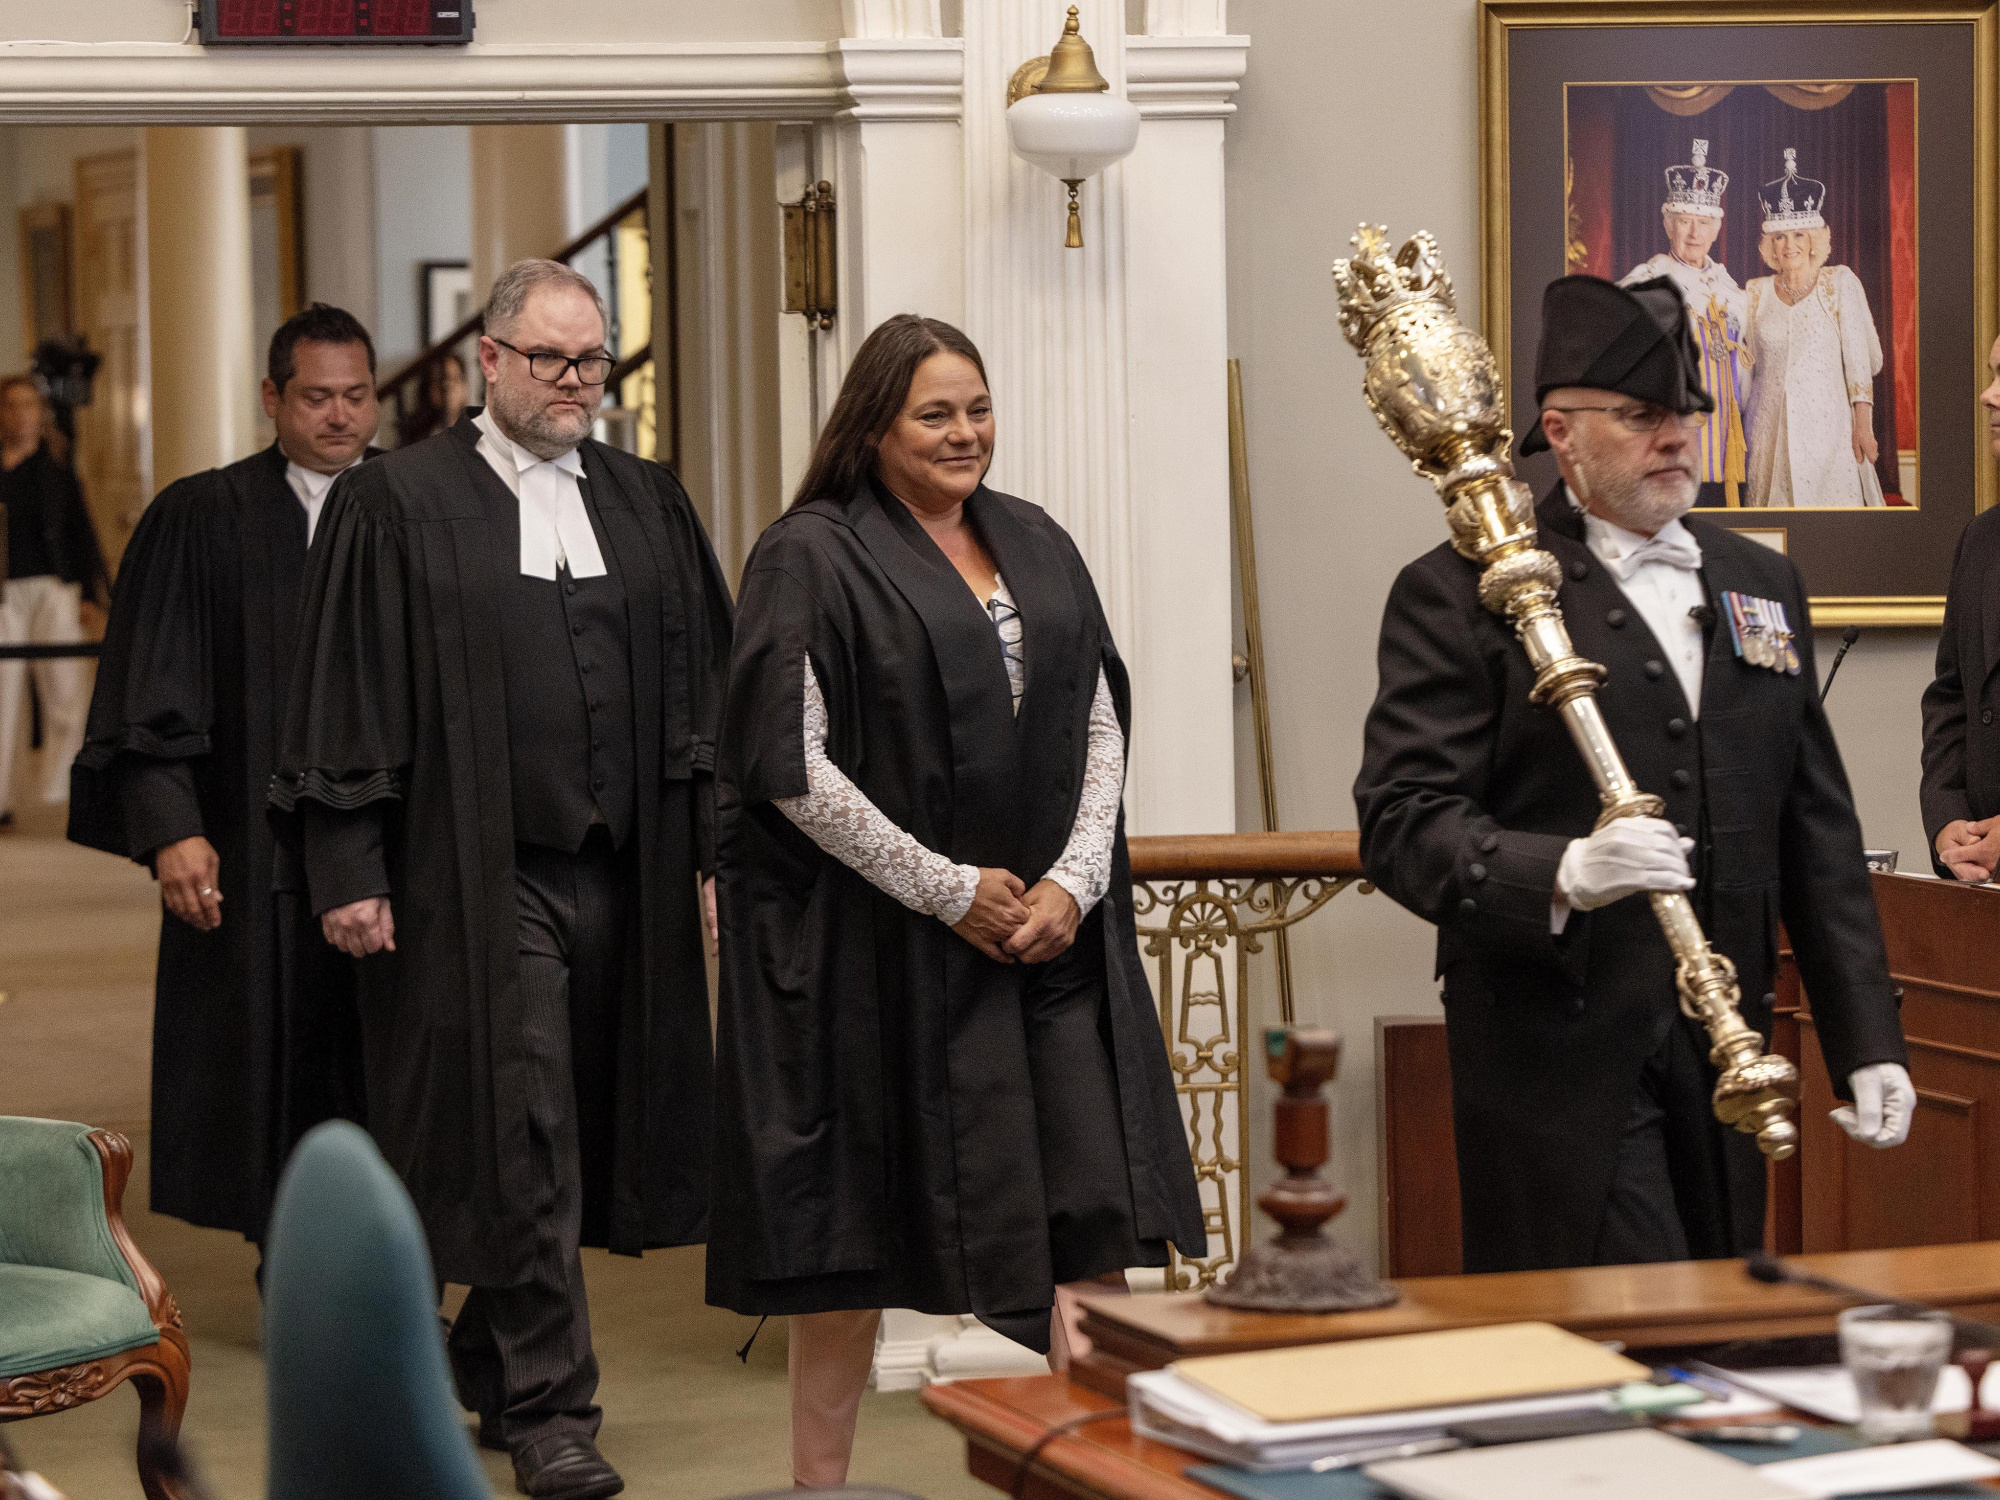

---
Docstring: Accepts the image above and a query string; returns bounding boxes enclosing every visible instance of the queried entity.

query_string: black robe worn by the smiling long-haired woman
[708,486,1206,1314]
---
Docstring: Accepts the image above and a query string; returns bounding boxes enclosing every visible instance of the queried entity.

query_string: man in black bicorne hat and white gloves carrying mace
[1354,276,1916,1272]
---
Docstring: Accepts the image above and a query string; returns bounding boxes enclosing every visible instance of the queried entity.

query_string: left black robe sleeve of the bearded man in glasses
[270,464,416,912]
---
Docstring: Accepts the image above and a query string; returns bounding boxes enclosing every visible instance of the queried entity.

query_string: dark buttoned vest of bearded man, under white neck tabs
[480,456,638,854]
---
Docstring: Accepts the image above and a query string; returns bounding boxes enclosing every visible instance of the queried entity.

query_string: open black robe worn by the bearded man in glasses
[272,418,730,1286]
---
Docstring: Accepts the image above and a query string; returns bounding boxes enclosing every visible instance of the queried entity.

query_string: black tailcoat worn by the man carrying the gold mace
[1354,486,1904,1270]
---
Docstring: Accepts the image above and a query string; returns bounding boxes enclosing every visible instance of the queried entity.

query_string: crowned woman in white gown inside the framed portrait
[1748,146,1886,508]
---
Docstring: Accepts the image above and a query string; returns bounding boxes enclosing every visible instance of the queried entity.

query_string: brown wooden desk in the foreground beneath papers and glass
[924,1240,2000,1500]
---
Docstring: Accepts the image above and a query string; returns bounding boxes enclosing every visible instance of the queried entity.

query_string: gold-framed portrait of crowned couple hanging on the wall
[1480,0,2000,626]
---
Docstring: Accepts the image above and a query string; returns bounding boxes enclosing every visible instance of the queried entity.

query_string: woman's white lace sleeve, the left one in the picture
[776,658,980,926]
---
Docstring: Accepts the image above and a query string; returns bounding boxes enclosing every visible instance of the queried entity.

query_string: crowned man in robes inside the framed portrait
[1620,140,1750,506]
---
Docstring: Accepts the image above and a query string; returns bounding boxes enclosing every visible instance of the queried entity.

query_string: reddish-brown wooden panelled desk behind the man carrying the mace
[1376,874,2000,1276]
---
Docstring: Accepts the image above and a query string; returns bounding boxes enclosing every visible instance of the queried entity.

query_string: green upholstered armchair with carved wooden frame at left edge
[0,1116,188,1500]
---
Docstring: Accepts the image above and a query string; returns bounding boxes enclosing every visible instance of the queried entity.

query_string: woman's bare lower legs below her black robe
[788,1270,1126,1490]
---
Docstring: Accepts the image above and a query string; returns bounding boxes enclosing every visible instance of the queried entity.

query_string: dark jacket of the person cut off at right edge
[1922,510,2000,878]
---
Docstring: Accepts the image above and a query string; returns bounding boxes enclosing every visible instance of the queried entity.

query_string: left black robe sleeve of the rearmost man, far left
[70,474,216,862]
